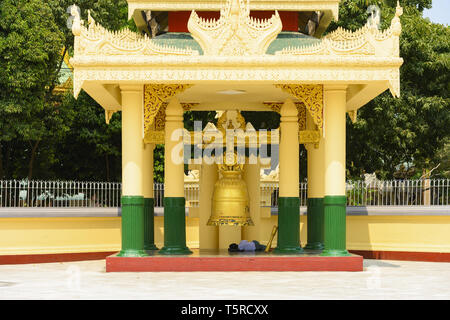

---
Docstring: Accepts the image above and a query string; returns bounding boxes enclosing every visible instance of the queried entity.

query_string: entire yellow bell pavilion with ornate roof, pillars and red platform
[70,0,403,271]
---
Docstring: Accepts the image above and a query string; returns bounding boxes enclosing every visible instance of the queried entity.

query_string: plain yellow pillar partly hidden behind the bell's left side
[199,161,219,249]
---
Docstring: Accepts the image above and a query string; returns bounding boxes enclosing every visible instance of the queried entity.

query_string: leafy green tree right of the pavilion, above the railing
[329,0,450,178]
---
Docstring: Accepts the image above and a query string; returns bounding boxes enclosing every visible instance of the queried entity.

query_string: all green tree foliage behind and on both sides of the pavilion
[0,0,450,182]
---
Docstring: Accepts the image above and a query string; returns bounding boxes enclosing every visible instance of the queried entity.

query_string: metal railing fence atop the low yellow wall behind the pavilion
[0,179,450,208]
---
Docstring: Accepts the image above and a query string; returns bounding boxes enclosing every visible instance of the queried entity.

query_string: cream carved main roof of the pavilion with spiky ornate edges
[70,0,403,134]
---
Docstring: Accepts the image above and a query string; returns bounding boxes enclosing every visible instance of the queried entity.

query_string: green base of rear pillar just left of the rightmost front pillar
[304,198,324,250]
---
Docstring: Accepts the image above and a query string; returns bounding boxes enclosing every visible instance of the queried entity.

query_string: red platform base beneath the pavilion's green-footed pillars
[106,249,363,272]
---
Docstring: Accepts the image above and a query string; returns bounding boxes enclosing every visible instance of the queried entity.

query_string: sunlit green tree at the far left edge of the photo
[0,0,65,177]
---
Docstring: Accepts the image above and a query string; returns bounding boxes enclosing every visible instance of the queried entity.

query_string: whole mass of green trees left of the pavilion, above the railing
[0,0,136,179]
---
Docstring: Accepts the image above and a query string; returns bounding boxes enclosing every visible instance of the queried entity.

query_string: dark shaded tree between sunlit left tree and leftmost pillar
[51,91,121,181]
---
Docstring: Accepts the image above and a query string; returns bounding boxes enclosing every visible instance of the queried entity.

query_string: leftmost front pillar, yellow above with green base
[118,85,147,257]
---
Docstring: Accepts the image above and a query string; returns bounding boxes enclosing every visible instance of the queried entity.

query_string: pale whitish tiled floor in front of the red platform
[0,260,450,300]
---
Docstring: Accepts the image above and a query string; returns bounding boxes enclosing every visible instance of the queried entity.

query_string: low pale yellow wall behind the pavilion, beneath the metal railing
[0,216,450,255]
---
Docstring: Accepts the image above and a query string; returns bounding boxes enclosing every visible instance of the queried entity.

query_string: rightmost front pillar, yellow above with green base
[322,85,349,256]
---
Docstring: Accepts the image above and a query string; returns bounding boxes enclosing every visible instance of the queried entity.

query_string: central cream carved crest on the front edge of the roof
[188,0,283,56]
